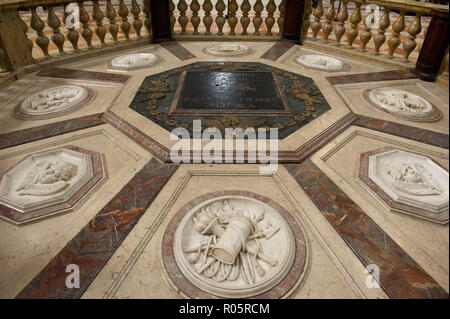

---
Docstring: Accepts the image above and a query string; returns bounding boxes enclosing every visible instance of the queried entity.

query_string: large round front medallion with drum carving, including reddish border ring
[162,191,307,298]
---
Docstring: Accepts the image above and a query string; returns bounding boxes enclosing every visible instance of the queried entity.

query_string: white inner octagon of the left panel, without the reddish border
[0,148,94,213]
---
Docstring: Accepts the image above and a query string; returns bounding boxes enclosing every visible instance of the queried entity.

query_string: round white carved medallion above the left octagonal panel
[15,84,93,119]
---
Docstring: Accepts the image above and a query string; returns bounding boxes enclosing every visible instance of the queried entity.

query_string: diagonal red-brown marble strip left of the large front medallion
[16,159,178,299]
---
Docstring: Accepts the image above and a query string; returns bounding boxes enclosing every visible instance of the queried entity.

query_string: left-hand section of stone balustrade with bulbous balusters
[0,0,151,72]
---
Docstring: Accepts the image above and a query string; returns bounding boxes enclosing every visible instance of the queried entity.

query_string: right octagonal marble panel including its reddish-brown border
[360,147,449,222]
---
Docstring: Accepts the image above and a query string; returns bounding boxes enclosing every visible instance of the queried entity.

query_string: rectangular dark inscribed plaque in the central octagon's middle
[169,71,290,115]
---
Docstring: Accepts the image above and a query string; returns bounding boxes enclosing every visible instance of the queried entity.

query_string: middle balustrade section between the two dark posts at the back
[169,0,285,39]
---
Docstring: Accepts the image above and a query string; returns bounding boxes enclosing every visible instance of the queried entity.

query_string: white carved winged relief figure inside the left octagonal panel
[16,160,77,196]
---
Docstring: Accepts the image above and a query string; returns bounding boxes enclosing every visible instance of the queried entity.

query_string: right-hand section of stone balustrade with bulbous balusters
[303,0,448,65]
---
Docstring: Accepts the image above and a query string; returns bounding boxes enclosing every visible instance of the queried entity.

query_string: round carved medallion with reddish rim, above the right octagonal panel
[367,87,441,121]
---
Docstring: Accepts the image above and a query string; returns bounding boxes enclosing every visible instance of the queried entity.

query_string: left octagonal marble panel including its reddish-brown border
[0,146,103,223]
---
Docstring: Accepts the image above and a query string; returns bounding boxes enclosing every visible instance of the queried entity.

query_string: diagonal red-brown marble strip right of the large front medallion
[285,159,448,299]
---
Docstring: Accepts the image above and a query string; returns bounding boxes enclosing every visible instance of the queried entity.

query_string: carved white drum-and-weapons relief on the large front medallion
[184,200,280,284]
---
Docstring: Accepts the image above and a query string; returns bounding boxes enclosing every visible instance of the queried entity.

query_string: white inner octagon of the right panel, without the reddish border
[368,149,449,214]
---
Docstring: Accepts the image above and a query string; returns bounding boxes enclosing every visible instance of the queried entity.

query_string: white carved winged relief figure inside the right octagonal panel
[385,163,443,196]
